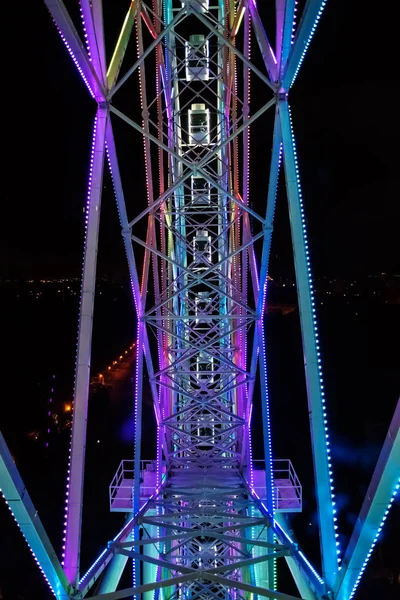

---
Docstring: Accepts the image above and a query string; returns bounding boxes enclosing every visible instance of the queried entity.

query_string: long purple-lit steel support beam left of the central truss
[64,107,108,585]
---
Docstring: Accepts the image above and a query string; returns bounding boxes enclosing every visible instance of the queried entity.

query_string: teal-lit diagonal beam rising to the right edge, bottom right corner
[335,399,400,600]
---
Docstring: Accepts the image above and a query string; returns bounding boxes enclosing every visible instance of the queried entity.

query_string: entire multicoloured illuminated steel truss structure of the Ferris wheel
[0,0,400,600]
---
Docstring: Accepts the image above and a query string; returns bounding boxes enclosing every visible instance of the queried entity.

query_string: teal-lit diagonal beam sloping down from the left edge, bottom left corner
[0,432,69,600]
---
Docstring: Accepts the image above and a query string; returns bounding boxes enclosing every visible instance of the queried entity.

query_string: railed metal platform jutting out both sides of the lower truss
[109,459,302,512]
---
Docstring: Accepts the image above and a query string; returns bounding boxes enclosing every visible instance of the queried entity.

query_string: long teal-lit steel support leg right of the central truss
[278,99,338,586]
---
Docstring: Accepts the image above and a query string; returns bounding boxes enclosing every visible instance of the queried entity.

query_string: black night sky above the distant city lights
[0,0,400,277]
